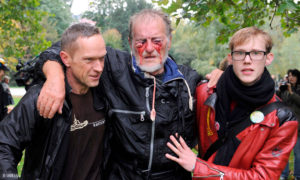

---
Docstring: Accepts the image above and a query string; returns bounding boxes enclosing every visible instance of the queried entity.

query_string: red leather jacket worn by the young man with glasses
[193,84,298,180]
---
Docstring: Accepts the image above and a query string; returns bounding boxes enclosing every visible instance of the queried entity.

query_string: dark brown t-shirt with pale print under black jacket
[61,90,105,180]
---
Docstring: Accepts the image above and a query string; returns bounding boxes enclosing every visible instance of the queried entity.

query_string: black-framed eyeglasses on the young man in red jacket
[231,51,267,61]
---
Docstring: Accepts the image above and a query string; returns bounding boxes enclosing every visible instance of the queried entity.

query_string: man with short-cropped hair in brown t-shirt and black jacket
[0,23,106,180]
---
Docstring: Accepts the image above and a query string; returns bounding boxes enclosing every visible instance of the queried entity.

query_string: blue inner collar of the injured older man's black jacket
[131,55,184,83]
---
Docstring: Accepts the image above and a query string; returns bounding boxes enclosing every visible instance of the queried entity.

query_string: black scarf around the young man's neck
[214,66,275,165]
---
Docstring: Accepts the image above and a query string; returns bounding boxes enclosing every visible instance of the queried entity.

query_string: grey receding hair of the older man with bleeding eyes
[129,9,173,40]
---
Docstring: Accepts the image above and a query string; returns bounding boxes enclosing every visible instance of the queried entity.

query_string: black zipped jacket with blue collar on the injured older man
[37,43,201,180]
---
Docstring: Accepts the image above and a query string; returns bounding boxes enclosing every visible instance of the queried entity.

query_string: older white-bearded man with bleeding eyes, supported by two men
[32,9,219,180]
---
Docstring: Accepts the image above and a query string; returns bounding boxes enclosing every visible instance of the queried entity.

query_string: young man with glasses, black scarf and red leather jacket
[166,27,298,180]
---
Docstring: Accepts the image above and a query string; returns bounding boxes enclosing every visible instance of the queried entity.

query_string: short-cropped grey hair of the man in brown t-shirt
[61,23,101,53]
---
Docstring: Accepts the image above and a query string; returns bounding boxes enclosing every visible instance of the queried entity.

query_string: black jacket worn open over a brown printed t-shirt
[0,84,104,180]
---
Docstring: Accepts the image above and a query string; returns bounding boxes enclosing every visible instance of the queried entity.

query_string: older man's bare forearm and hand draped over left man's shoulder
[37,61,65,118]
